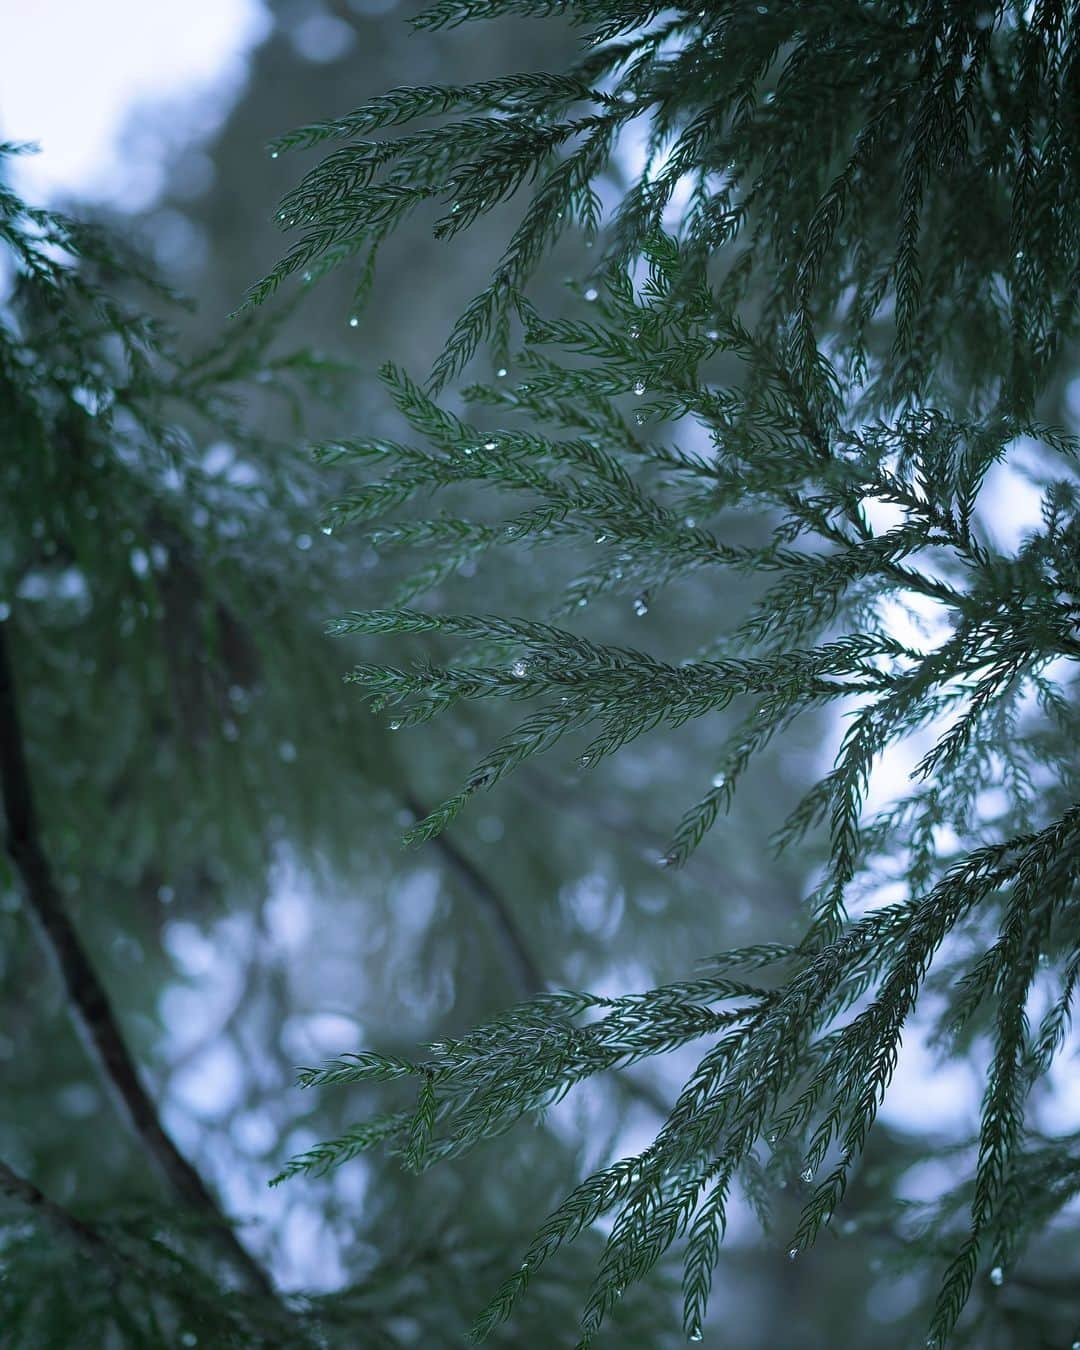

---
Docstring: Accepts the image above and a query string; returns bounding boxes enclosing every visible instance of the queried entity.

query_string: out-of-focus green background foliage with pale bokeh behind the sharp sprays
[0,0,1067,1350]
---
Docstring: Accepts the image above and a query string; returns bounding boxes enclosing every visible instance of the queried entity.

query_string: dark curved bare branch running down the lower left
[0,622,275,1299]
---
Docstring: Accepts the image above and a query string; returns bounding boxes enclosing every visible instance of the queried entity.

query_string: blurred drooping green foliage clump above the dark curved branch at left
[0,142,361,895]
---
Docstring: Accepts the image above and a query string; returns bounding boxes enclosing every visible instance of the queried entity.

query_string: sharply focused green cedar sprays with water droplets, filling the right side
[259,0,1080,1350]
